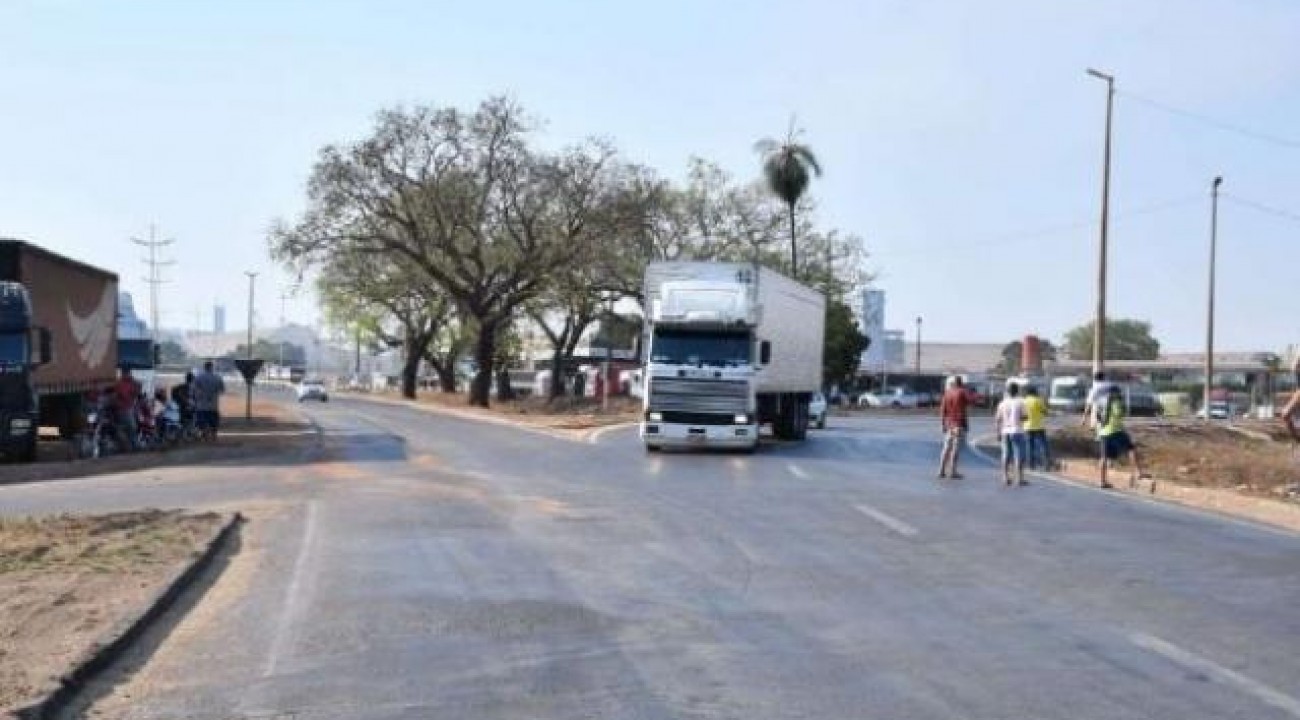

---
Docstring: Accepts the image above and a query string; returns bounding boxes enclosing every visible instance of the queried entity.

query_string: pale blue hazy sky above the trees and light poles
[0,0,1300,351]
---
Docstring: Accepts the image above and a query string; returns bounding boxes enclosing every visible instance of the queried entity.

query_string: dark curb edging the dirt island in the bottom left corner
[17,512,246,720]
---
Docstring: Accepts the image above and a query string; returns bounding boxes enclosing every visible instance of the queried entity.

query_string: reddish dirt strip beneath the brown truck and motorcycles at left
[0,387,313,485]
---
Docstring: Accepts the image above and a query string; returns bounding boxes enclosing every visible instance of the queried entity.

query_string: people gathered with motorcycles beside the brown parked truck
[95,361,226,450]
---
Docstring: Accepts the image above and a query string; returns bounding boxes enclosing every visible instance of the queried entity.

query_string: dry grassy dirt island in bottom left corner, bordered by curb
[0,509,225,715]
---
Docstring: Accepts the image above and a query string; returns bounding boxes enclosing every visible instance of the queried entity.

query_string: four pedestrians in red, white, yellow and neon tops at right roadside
[939,373,1149,487]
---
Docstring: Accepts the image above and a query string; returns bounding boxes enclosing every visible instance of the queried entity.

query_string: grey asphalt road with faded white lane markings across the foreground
[0,400,1300,720]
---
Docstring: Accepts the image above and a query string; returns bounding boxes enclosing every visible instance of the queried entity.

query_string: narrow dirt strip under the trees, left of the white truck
[358,392,641,430]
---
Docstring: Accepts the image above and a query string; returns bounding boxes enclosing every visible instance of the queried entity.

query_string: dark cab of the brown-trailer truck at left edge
[0,282,49,461]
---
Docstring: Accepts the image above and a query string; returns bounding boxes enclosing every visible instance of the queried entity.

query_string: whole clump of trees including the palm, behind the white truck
[269,97,866,407]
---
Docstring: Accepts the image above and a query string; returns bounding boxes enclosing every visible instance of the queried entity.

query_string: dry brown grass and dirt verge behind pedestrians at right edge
[1052,420,1300,500]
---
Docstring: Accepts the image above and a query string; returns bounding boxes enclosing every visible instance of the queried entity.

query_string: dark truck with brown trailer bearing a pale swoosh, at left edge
[0,238,117,460]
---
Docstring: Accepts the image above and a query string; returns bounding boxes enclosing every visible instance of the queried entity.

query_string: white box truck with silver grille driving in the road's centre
[641,263,826,451]
